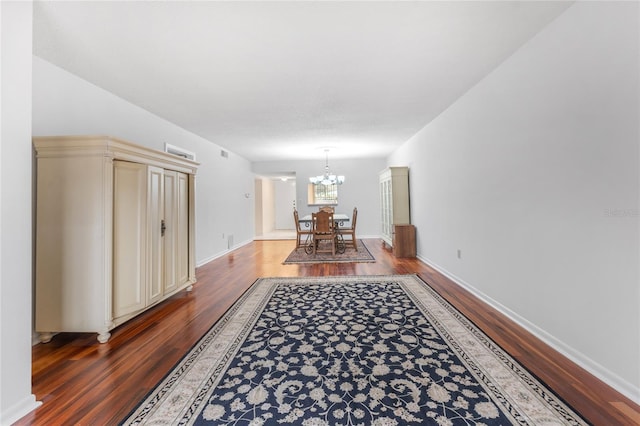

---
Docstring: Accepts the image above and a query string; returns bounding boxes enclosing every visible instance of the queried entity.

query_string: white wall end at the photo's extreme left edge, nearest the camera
[0,2,38,425]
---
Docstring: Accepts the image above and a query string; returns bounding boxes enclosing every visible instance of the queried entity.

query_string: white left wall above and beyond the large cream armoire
[33,56,255,265]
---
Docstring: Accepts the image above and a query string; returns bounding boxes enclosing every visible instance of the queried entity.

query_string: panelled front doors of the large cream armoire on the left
[113,161,189,318]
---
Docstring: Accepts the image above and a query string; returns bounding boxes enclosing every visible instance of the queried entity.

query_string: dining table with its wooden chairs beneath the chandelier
[293,206,358,256]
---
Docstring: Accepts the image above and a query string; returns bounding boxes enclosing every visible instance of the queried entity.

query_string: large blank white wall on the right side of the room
[389,2,640,401]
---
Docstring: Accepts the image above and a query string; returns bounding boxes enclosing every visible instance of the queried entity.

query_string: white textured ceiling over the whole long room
[34,1,569,161]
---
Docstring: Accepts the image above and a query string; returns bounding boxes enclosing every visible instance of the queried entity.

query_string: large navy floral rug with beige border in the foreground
[123,275,587,426]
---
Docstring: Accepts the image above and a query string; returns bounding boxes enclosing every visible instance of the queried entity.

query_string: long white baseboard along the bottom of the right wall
[418,255,640,404]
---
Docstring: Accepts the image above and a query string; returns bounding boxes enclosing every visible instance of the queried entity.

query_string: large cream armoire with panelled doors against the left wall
[33,136,198,343]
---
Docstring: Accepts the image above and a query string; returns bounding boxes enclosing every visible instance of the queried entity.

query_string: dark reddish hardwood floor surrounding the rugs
[16,239,640,426]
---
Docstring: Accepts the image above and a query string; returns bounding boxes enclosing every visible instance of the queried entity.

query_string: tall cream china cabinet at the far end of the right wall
[380,167,411,246]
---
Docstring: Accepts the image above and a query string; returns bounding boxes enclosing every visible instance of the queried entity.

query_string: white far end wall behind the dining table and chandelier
[252,158,386,238]
